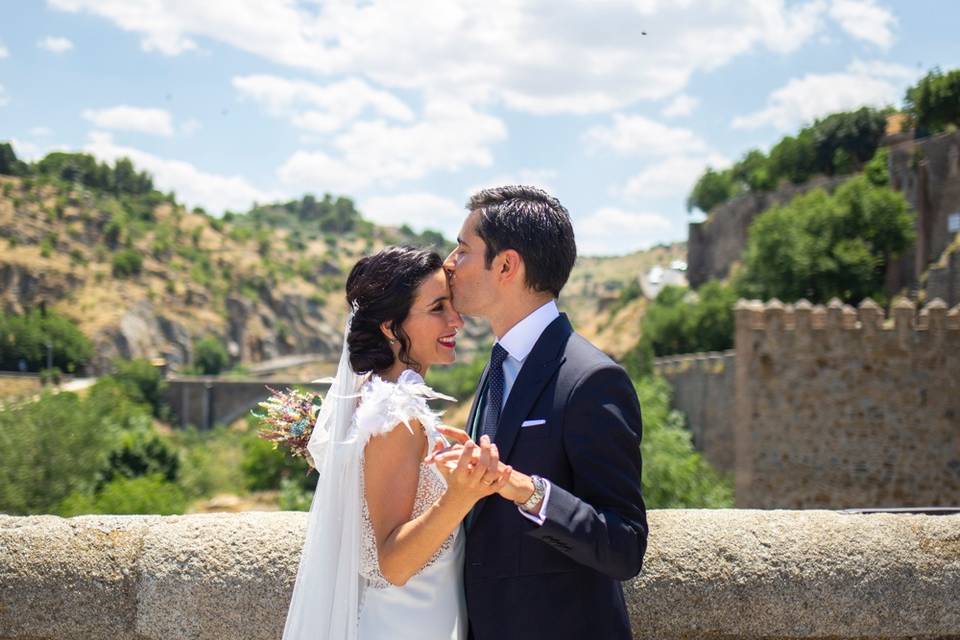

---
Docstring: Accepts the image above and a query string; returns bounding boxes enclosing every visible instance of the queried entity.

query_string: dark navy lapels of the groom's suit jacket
[468,313,573,527]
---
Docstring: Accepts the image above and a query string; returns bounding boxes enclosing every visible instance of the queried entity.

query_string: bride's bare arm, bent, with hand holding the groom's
[364,421,510,585]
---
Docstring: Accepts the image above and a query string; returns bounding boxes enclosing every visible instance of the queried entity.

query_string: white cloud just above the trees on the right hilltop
[731,61,918,131]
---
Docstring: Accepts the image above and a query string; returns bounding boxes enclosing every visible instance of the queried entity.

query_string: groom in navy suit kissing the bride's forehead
[444,186,647,640]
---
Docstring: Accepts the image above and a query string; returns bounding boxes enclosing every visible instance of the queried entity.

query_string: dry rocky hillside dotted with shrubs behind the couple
[0,146,685,373]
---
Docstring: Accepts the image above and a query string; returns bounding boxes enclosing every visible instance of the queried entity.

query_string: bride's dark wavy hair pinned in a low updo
[347,247,443,373]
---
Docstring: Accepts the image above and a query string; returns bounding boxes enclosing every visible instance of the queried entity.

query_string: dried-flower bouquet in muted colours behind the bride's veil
[253,387,320,468]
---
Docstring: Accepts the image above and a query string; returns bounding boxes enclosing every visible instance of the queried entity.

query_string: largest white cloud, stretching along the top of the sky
[48,0,826,114]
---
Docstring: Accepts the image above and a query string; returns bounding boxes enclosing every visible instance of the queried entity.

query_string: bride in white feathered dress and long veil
[283,247,511,640]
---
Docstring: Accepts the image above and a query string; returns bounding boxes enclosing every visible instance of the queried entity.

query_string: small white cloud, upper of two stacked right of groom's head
[583,113,707,156]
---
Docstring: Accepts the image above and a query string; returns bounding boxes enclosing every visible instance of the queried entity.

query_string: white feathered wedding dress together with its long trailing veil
[283,352,467,640]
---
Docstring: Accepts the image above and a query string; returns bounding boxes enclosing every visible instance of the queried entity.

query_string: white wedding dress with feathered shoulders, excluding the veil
[356,369,467,640]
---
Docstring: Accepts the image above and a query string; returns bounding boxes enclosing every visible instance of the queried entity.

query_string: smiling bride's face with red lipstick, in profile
[403,269,463,372]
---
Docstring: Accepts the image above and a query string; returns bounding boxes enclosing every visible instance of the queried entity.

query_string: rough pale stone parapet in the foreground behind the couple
[0,510,960,640]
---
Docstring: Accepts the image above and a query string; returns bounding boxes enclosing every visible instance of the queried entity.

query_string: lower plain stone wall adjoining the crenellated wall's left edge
[654,350,736,473]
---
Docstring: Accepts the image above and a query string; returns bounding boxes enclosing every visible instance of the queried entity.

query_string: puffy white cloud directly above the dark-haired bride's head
[278,98,507,192]
